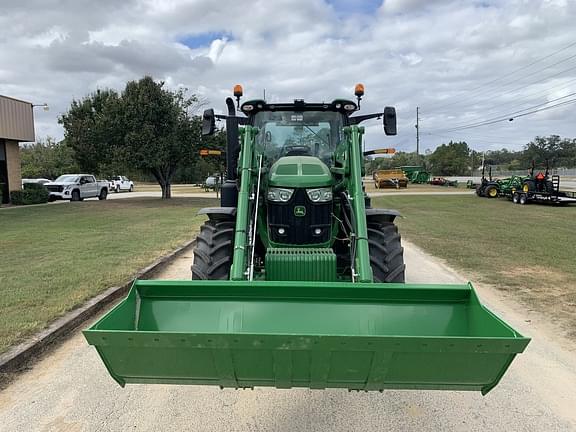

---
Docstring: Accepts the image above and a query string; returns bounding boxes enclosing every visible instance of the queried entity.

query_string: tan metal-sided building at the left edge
[0,95,35,203]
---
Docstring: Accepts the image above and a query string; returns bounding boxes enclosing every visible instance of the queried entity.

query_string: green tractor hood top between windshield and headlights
[269,156,332,188]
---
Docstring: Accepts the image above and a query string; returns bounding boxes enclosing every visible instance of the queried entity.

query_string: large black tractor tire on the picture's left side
[191,220,235,280]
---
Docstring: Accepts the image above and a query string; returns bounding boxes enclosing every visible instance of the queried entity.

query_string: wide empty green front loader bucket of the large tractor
[84,280,530,393]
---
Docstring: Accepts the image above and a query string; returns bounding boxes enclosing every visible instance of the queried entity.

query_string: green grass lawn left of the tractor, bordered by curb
[0,198,217,352]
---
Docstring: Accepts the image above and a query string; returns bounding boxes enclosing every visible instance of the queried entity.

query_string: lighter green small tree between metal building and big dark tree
[20,137,78,179]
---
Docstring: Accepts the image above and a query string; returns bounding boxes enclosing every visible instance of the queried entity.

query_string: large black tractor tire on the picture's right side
[368,222,406,283]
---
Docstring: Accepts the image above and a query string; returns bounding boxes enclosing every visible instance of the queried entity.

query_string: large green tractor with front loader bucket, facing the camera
[84,85,529,394]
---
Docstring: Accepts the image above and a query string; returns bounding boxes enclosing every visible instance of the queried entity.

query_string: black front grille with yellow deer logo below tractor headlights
[267,189,332,245]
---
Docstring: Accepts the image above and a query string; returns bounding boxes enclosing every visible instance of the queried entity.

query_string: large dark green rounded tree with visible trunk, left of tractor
[60,76,201,198]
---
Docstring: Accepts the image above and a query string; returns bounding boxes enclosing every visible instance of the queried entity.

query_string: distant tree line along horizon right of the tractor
[365,135,576,176]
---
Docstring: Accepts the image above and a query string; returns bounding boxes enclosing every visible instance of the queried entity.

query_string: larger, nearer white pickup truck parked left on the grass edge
[44,174,108,201]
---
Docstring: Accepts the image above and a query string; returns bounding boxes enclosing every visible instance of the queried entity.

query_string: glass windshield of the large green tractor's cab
[254,111,342,166]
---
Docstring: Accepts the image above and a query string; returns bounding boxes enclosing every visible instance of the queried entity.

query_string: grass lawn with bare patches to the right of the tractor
[373,195,576,337]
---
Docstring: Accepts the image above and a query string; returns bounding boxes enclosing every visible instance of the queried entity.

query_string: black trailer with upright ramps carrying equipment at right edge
[510,160,576,204]
